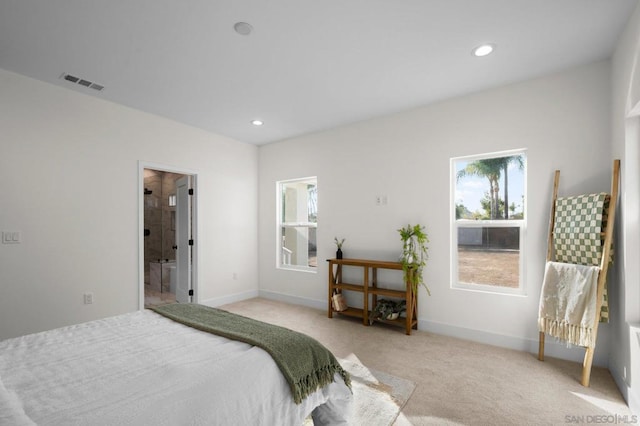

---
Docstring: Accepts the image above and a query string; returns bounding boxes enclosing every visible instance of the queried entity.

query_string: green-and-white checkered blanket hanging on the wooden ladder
[553,193,613,322]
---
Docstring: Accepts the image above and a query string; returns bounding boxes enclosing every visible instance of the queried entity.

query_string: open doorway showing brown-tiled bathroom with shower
[139,163,196,309]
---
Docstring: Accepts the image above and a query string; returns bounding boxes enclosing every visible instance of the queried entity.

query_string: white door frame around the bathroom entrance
[137,160,199,310]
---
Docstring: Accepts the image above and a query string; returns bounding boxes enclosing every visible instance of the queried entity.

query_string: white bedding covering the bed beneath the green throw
[0,310,353,426]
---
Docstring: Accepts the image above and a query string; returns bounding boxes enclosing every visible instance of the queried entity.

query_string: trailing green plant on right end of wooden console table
[398,225,431,295]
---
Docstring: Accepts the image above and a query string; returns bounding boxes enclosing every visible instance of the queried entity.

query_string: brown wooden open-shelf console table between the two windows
[327,259,418,335]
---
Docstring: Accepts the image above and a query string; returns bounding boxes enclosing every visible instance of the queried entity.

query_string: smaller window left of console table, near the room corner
[277,177,318,272]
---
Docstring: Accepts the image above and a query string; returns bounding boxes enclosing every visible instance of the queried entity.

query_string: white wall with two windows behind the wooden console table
[259,62,612,364]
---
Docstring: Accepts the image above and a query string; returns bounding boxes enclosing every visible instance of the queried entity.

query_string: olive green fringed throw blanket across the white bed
[151,303,351,404]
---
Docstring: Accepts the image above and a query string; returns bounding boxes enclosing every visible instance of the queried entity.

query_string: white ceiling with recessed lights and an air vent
[0,0,639,144]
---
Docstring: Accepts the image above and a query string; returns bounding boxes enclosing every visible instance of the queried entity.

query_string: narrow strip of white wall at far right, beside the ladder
[609,2,640,413]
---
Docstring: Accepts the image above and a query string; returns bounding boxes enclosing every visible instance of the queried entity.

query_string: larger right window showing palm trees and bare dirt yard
[451,150,526,294]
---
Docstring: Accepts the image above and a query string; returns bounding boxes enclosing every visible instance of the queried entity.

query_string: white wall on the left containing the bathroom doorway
[0,70,258,339]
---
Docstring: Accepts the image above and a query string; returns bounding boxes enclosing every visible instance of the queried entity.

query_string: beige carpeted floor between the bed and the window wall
[221,299,632,426]
